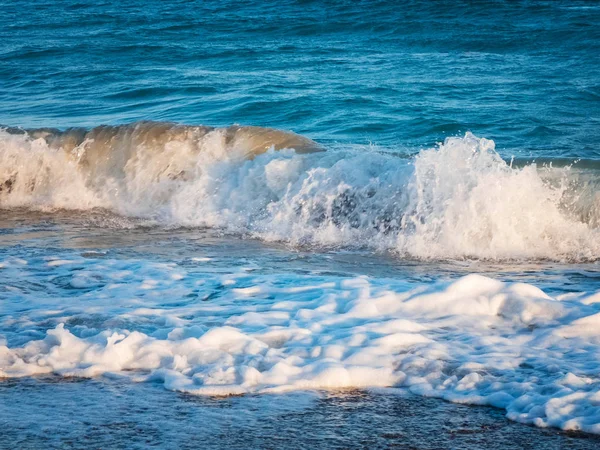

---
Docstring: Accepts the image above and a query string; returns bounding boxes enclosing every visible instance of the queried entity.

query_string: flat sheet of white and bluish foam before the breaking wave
[0,260,600,433]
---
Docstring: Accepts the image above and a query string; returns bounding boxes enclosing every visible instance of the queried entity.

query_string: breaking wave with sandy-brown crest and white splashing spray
[0,122,600,261]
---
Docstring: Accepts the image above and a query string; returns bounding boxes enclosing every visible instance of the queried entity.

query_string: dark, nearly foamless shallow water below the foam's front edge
[0,378,600,449]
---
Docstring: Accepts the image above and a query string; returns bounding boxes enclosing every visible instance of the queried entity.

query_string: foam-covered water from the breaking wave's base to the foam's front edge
[0,210,600,439]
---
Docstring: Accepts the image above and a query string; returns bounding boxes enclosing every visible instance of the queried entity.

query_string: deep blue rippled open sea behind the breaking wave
[0,0,600,159]
